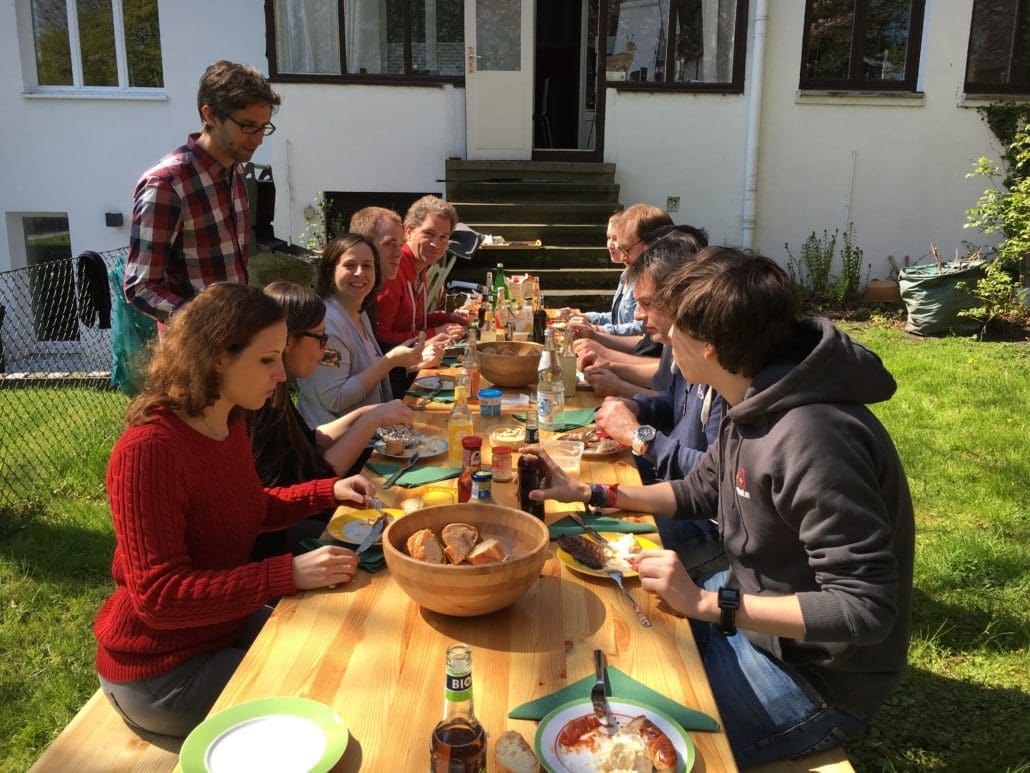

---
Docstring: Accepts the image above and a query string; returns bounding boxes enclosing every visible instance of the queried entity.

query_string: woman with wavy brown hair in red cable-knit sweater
[94,282,374,736]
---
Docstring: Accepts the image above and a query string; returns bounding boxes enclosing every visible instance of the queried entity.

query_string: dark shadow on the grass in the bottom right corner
[847,669,1030,772]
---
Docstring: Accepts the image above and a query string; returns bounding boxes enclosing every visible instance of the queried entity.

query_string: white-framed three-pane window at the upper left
[29,0,164,91]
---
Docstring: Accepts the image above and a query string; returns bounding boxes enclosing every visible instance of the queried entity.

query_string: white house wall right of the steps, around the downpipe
[605,0,1000,277]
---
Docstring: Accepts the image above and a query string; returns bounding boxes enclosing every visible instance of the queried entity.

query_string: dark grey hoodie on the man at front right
[673,318,915,711]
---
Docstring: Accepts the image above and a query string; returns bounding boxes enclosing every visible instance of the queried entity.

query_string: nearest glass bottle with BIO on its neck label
[430,644,486,773]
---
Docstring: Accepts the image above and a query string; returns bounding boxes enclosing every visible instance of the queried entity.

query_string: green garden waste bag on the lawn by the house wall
[898,261,985,336]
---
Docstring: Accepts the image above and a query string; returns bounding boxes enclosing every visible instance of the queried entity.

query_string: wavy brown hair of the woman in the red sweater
[126,281,285,427]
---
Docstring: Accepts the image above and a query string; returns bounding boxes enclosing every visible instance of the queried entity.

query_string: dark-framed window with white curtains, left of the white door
[268,0,465,82]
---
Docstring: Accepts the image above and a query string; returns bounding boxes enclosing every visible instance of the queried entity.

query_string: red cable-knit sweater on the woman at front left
[93,410,336,682]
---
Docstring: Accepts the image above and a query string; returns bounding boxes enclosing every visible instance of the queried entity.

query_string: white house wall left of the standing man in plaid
[0,0,265,271]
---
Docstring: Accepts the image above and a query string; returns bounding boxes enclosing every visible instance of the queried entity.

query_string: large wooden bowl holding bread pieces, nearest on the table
[383,503,550,617]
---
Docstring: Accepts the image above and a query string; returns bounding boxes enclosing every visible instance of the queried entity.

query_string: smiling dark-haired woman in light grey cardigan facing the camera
[297,233,439,427]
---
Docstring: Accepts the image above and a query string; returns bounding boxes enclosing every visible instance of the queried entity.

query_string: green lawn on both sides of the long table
[0,325,1030,773]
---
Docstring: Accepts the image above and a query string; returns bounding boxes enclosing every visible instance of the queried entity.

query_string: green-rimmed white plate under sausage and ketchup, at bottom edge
[535,698,694,773]
